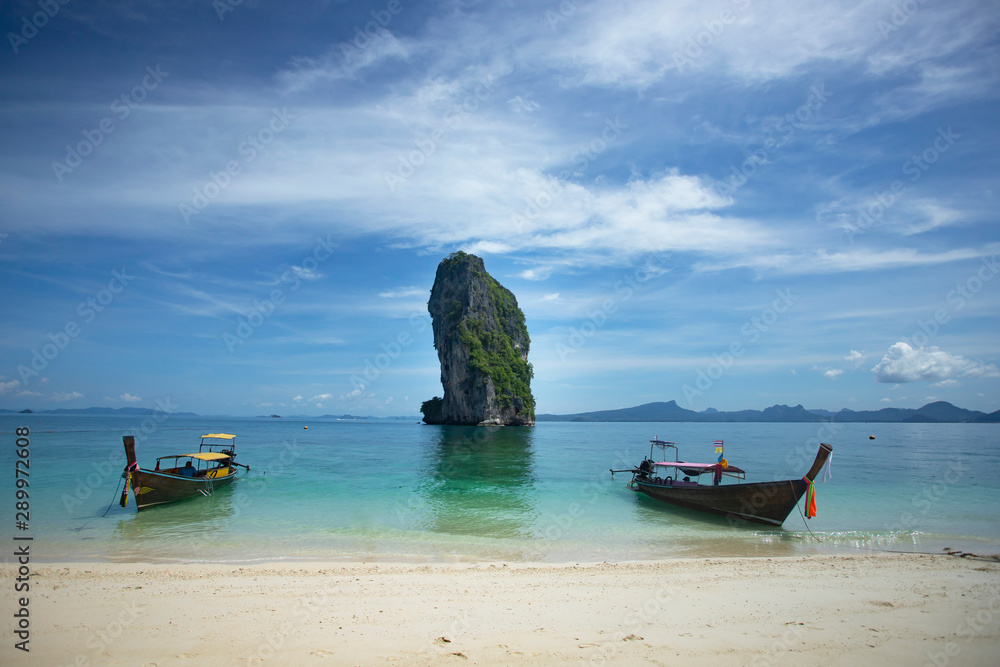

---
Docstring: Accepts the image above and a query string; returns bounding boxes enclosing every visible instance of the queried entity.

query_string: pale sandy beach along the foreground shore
[2,554,1000,666]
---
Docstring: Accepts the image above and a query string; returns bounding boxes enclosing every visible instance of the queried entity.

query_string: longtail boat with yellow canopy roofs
[119,433,250,510]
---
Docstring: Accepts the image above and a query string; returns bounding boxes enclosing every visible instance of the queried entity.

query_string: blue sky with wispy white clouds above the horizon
[0,0,1000,416]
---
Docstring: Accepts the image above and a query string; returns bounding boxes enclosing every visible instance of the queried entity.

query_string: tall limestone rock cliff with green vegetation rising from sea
[421,252,535,426]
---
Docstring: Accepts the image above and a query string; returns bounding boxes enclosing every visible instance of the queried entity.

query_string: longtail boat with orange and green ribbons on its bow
[611,439,833,526]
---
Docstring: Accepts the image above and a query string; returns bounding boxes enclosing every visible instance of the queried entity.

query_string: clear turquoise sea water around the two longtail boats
[0,415,1000,562]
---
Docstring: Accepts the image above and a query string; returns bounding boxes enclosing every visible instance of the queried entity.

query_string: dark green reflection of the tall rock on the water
[417,426,537,538]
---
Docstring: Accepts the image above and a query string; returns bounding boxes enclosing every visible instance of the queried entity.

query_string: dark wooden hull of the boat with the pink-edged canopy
[635,479,807,526]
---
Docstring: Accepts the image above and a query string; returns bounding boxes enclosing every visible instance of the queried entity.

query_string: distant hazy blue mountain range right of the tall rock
[535,401,1000,424]
